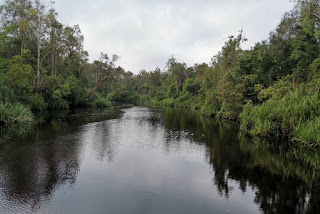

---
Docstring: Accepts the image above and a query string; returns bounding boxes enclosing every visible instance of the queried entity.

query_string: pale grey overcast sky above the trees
[51,0,293,73]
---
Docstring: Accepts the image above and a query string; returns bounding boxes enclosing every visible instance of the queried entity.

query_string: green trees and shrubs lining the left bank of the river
[0,0,133,125]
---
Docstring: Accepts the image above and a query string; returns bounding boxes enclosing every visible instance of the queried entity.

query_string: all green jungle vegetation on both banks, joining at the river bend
[0,0,320,146]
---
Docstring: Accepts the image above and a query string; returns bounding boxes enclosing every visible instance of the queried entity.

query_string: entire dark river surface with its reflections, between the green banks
[0,107,320,214]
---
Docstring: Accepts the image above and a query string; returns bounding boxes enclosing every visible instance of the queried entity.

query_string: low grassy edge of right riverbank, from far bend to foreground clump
[139,92,320,148]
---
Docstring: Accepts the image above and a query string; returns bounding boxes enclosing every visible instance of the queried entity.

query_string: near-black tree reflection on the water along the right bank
[163,109,320,213]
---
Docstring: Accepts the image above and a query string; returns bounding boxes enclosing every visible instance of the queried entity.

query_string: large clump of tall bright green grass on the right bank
[240,86,320,146]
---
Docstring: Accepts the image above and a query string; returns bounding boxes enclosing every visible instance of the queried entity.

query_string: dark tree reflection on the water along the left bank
[0,109,121,210]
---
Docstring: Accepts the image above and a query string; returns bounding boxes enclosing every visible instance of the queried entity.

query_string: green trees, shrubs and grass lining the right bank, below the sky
[134,0,320,145]
